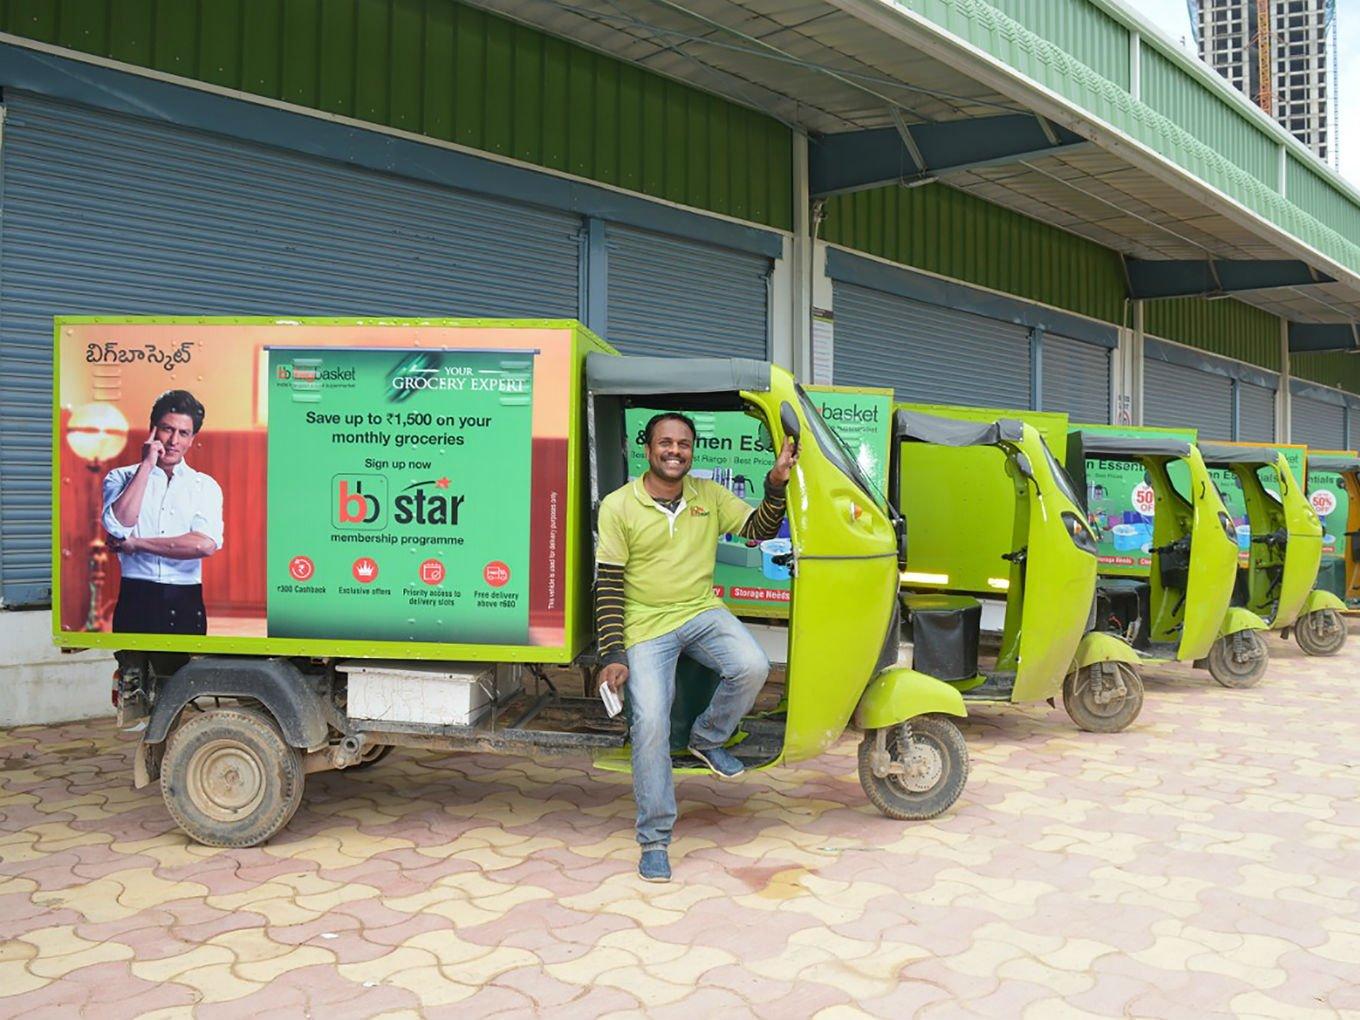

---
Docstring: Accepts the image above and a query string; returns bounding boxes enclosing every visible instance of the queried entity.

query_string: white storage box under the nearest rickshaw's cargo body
[336,658,520,726]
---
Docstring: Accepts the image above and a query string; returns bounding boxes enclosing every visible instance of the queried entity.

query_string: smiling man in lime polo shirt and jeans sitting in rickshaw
[596,413,798,881]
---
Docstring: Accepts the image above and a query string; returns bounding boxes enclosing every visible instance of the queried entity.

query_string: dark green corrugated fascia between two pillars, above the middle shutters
[821,184,1125,324]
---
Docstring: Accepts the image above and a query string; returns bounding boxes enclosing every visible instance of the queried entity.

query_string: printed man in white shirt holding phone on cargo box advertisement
[99,389,222,634]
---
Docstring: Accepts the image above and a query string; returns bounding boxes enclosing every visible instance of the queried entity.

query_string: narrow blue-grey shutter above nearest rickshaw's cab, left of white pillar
[605,223,771,359]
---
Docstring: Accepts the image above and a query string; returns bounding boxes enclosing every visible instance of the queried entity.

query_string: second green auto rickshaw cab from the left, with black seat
[889,409,1142,733]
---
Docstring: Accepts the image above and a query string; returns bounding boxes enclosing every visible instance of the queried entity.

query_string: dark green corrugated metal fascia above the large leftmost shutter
[0,0,793,230]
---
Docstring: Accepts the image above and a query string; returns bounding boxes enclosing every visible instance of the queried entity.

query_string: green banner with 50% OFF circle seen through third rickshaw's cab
[1074,426,1195,577]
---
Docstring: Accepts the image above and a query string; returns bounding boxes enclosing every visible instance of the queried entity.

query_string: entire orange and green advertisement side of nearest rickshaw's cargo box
[53,318,573,661]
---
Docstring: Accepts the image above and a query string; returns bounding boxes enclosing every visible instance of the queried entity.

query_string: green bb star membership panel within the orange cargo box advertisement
[268,348,533,645]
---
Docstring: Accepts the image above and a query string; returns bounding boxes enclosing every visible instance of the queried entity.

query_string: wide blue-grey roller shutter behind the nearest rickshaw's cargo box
[0,90,581,605]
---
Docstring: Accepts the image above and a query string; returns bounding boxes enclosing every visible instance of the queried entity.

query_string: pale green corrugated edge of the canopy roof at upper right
[896,0,1360,284]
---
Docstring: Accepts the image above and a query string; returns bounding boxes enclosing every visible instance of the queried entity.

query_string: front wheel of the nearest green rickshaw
[860,715,968,821]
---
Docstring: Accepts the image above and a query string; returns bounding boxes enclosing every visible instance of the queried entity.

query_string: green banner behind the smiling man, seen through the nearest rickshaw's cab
[626,386,892,617]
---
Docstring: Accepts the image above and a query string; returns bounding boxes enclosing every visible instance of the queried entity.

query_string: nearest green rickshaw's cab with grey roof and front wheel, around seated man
[586,354,968,819]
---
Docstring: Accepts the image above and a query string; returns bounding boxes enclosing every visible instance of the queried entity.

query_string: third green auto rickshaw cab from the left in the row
[1068,428,1269,687]
